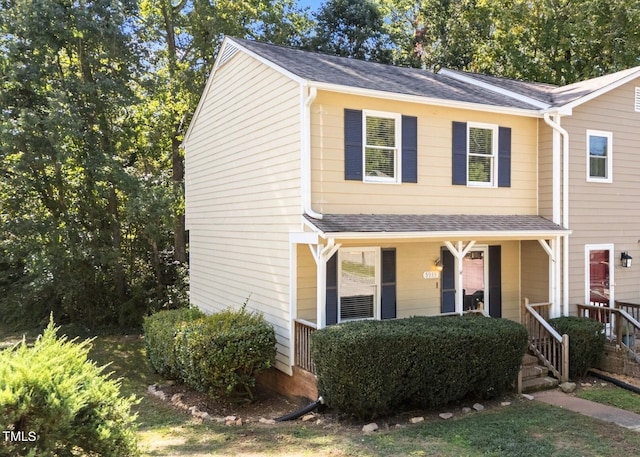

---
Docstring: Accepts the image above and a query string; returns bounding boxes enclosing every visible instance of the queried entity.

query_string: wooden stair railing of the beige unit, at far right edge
[577,302,640,360]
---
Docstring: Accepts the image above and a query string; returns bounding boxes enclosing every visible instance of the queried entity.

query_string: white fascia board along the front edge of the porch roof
[310,230,571,240]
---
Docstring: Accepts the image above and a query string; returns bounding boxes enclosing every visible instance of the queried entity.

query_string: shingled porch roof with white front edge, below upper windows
[304,214,571,240]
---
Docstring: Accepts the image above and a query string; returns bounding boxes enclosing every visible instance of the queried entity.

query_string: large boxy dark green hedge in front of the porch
[311,316,527,418]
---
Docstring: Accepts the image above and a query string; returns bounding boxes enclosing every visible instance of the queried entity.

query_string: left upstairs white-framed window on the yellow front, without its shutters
[362,111,400,183]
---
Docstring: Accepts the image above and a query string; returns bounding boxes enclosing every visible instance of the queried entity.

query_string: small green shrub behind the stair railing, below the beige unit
[549,316,605,379]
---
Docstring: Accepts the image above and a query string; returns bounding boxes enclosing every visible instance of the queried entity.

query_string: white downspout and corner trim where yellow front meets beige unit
[544,113,569,316]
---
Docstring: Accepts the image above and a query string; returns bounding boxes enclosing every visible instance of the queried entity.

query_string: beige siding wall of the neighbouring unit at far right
[562,81,640,312]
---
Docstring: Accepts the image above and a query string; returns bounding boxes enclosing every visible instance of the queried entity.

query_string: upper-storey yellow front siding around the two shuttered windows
[311,92,538,214]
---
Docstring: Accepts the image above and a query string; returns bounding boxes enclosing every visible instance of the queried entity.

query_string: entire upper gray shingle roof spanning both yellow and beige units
[230,38,640,111]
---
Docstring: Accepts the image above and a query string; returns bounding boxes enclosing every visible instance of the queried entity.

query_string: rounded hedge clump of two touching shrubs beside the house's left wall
[145,306,276,397]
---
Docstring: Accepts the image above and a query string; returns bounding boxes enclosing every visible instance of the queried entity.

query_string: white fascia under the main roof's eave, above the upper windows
[309,81,542,118]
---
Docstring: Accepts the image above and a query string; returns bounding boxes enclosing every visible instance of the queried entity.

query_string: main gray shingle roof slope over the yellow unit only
[231,38,537,110]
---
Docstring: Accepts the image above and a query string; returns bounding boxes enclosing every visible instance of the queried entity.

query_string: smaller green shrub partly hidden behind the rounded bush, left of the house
[143,308,204,379]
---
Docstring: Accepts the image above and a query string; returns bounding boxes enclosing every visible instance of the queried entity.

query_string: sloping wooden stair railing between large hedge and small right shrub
[523,298,569,382]
